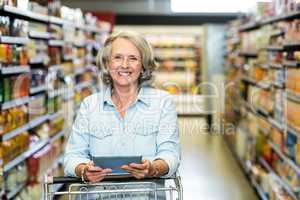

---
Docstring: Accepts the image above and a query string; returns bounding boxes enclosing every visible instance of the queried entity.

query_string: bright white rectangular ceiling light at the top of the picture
[171,0,271,13]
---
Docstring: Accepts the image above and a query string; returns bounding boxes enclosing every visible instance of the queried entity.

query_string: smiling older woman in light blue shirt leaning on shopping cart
[64,32,180,198]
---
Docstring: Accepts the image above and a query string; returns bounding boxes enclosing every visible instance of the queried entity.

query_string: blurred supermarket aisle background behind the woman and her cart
[0,0,300,200]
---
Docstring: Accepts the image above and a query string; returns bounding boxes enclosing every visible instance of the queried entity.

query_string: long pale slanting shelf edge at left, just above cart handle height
[3,140,48,173]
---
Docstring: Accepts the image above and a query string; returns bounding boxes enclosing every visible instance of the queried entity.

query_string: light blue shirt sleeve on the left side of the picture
[64,101,90,176]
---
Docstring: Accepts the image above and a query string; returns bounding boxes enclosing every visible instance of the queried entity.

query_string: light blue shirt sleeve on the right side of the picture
[154,95,181,178]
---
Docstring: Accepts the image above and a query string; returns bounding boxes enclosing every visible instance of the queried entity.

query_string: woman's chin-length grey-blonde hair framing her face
[96,31,157,85]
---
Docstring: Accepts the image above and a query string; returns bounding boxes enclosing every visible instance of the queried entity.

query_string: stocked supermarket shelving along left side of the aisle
[0,1,110,199]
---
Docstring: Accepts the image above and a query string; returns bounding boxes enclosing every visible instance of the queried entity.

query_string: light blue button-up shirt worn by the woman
[64,87,180,177]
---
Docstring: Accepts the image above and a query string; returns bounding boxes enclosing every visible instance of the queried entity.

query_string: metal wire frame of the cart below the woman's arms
[43,174,183,200]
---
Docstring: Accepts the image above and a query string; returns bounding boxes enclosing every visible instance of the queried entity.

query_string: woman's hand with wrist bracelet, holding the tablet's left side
[76,161,112,183]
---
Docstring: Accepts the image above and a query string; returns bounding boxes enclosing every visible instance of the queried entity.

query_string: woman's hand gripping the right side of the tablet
[121,160,154,179]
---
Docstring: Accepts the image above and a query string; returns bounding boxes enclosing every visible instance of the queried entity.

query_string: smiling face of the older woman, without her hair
[109,38,142,87]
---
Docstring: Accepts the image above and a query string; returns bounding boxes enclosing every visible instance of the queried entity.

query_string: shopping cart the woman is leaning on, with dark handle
[44,173,183,200]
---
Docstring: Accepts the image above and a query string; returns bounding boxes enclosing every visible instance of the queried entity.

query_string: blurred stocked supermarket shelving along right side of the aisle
[224,5,300,200]
